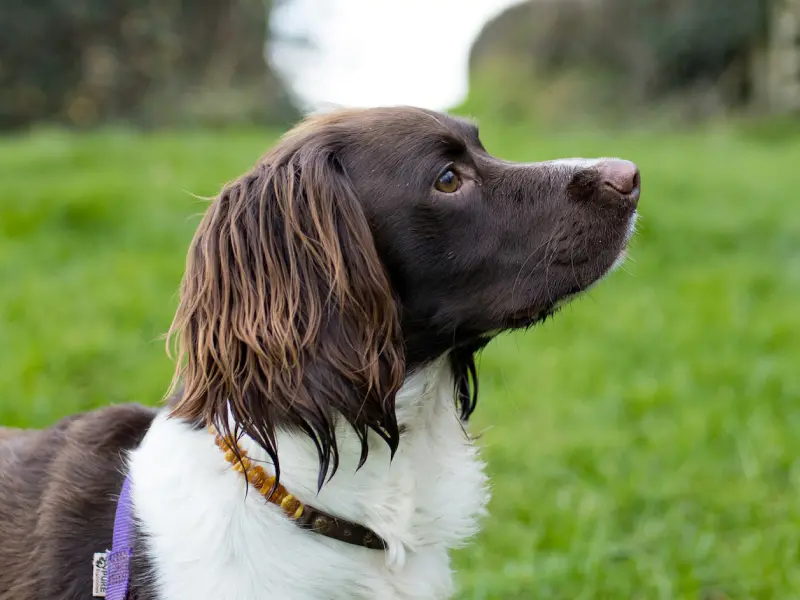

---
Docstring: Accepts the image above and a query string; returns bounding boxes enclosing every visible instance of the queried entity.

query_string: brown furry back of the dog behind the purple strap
[0,405,155,600]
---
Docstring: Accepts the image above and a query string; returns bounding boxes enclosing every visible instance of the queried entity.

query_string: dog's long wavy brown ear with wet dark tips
[169,136,405,486]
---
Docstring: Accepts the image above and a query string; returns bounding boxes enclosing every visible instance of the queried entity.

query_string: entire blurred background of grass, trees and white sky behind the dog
[0,0,800,600]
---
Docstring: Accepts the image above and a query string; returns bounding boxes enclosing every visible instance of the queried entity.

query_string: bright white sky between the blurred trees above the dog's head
[269,0,519,110]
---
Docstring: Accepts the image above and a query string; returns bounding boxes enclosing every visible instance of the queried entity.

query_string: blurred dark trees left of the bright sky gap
[0,0,295,128]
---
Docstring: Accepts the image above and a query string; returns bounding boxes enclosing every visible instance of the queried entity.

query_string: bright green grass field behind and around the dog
[0,123,800,600]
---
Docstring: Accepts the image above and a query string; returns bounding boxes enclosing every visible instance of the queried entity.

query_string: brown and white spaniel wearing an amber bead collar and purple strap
[0,107,640,600]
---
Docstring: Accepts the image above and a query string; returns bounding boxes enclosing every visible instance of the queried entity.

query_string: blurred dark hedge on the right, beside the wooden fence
[471,0,800,118]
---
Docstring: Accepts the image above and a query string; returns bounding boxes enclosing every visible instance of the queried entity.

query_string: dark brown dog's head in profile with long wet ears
[171,108,639,484]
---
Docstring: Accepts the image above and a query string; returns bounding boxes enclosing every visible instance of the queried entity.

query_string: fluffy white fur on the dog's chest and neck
[130,362,488,600]
